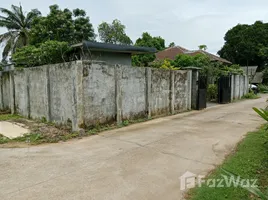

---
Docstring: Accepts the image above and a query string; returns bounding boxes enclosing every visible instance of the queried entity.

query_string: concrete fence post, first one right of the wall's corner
[114,65,122,125]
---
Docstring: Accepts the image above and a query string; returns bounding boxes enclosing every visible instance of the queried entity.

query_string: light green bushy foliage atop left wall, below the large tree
[12,41,71,67]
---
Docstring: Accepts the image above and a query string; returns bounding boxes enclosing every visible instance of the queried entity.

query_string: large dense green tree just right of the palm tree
[30,5,95,45]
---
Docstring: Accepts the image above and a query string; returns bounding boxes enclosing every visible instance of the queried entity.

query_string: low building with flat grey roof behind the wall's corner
[72,41,157,66]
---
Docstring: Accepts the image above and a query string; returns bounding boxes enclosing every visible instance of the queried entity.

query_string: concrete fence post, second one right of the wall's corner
[145,67,152,119]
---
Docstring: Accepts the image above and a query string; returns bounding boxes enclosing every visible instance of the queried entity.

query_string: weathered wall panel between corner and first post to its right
[83,63,116,126]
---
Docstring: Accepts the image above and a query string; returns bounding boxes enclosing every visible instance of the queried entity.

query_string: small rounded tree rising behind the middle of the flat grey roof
[98,19,132,45]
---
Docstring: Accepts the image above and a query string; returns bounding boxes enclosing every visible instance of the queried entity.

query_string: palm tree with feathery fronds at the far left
[0,5,41,61]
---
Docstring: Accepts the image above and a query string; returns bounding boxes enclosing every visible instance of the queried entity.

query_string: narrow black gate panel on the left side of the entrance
[197,76,207,110]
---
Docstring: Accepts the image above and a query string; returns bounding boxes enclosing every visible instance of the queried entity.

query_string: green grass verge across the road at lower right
[187,125,268,200]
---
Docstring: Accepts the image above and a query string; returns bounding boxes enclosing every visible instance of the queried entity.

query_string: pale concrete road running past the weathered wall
[0,96,267,200]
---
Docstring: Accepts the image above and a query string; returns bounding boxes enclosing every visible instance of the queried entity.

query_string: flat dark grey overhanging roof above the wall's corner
[72,41,157,54]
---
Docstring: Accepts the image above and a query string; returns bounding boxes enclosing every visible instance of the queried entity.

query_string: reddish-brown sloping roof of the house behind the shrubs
[155,46,232,65]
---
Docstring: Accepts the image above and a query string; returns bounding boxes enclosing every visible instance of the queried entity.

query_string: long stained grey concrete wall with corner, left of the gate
[0,61,192,130]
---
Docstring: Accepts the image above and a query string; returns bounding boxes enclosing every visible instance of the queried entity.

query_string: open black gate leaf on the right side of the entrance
[218,76,232,104]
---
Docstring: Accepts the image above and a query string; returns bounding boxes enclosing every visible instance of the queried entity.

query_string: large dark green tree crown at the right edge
[218,21,268,66]
